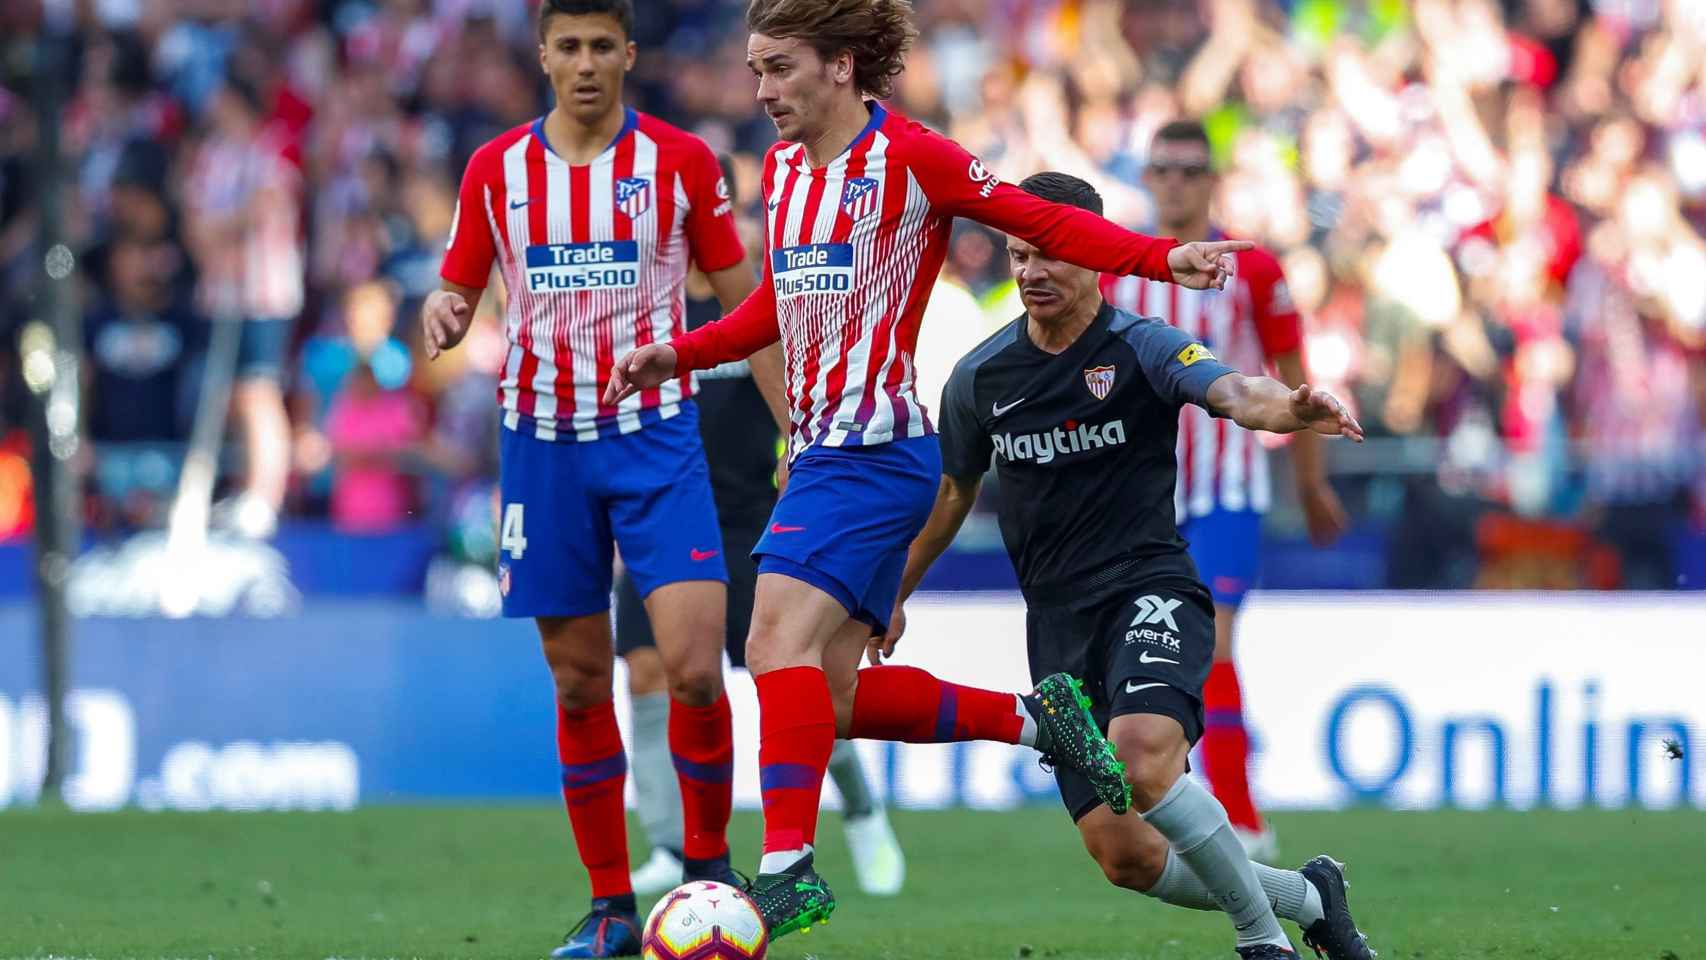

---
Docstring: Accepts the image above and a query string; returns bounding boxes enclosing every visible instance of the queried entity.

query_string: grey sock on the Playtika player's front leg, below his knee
[1143,776,1291,950]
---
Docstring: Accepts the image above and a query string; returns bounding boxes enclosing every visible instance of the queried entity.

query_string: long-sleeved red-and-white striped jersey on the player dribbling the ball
[672,104,1175,452]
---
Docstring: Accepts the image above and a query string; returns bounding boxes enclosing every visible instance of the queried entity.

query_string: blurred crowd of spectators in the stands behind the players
[0,0,1706,585]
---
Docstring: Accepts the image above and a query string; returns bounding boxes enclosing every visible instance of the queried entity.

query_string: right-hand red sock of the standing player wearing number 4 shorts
[669,696,735,859]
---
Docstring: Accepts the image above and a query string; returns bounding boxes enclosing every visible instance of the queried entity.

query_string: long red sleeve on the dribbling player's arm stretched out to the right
[904,123,1179,281]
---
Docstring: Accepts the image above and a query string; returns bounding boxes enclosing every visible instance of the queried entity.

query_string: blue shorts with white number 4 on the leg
[498,402,728,617]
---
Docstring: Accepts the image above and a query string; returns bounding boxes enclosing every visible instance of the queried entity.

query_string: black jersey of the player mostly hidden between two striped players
[686,298,781,529]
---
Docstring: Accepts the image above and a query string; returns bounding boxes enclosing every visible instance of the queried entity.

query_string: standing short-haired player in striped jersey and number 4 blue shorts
[421,0,780,957]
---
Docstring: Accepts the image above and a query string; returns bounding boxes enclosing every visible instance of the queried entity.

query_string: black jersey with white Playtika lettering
[938,304,1235,602]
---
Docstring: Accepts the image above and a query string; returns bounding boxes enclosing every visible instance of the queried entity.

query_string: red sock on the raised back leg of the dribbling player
[848,667,1025,743]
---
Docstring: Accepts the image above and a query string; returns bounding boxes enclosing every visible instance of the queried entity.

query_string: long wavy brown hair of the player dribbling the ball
[747,0,918,101]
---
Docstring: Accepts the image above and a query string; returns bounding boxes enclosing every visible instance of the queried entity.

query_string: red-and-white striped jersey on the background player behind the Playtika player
[1102,249,1303,523]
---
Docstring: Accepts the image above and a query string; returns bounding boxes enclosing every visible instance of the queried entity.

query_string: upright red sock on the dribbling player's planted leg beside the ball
[754,667,836,853]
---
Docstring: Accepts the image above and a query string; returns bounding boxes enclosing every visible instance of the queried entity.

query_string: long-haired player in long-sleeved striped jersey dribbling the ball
[604,0,1250,938]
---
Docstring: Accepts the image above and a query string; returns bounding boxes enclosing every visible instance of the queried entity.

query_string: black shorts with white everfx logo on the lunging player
[1025,575,1215,820]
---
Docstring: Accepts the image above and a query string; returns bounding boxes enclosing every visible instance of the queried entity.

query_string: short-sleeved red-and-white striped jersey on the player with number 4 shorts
[440,111,744,440]
